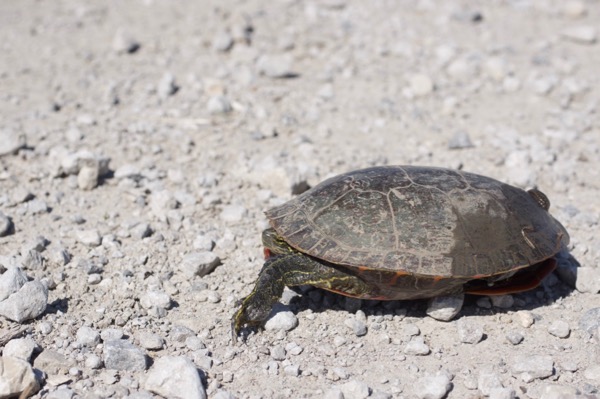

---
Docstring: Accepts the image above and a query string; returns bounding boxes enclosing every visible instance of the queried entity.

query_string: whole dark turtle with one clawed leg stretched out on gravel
[232,166,569,335]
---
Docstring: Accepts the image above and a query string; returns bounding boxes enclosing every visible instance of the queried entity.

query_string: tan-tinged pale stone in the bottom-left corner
[0,356,40,398]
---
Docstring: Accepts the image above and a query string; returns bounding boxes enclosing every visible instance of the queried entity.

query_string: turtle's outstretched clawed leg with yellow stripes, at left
[232,253,371,336]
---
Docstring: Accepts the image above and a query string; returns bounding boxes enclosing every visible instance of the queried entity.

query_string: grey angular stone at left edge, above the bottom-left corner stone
[0,280,48,323]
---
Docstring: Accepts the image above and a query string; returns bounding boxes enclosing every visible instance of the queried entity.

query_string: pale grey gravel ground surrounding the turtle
[0,0,600,399]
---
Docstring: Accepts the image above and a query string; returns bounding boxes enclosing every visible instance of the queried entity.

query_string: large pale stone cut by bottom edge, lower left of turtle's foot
[144,356,206,399]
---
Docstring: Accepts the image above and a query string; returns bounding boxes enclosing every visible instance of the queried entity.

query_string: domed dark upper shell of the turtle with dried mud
[266,166,569,278]
